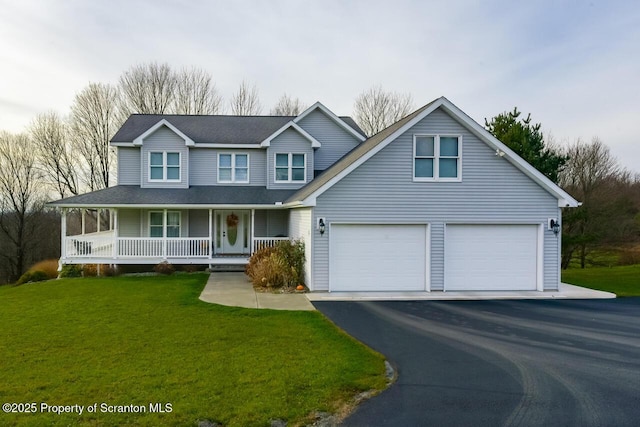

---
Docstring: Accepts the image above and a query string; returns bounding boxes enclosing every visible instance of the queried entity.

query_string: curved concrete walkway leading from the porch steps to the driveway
[200,273,315,310]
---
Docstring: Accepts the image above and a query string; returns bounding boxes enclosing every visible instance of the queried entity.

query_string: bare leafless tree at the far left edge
[0,132,44,281]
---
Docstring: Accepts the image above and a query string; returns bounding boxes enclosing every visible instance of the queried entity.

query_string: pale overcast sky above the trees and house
[0,0,640,172]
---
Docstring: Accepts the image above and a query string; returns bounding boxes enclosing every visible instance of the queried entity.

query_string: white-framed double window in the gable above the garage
[413,135,462,181]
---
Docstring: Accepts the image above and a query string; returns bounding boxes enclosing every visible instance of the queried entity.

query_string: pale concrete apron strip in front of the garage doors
[305,283,616,301]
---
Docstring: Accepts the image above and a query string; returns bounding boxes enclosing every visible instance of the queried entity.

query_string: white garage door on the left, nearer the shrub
[329,224,428,291]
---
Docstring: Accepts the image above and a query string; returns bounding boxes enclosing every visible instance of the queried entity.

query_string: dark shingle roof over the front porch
[49,185,295,208]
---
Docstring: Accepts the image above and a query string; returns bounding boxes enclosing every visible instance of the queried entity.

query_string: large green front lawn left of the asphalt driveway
[0,274,385,426]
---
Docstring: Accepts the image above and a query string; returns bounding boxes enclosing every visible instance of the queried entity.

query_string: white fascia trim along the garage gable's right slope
[437,97,579,208]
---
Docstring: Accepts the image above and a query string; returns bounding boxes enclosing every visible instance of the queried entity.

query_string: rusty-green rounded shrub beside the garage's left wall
[245,240,304,288]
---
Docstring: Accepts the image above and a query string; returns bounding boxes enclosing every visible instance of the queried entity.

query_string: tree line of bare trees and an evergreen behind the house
[0,63,640,283]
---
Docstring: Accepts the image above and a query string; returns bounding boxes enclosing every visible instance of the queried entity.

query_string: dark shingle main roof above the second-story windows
[111,114,364,144]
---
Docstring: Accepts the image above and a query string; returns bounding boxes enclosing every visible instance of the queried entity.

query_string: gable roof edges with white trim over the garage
[286,97,580,211]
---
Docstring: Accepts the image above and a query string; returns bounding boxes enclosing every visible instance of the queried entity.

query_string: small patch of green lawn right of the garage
[562,265,640,297]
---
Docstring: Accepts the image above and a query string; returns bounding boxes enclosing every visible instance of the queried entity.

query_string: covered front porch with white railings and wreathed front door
[60,207,289,266]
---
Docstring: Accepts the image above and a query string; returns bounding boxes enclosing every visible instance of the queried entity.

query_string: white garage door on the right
[444,224,538,291]
